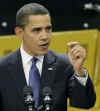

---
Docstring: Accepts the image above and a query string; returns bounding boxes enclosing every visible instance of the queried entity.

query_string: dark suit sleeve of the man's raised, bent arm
[61,56,96,109]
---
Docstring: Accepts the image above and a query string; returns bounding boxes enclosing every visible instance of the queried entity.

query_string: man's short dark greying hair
[16,3,50,28]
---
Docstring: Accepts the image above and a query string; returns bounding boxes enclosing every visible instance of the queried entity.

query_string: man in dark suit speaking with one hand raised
[0,3,96,111]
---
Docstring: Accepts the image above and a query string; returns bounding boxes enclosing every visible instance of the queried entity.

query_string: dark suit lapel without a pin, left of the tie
[8,50,26,99]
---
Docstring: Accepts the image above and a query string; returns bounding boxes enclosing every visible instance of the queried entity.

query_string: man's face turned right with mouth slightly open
[19,14,52,56]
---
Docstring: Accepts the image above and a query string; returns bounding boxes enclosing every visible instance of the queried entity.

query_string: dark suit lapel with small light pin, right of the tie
[39,52,56,105]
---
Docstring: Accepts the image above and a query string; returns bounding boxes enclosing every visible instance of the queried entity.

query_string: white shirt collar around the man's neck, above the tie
[20,44,44,64]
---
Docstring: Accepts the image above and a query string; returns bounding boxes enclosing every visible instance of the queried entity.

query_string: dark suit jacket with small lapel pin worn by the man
[0,50,96,111]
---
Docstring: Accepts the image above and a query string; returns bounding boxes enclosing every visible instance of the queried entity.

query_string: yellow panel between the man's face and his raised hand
[50,30,98,79]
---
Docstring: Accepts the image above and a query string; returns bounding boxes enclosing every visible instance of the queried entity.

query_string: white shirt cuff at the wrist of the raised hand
[74,69,88,86]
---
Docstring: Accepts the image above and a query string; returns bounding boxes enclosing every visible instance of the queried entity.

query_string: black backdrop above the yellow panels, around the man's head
[0,0,100,35]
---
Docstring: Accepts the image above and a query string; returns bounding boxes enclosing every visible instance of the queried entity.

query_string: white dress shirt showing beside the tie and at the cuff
[20,45,88,86]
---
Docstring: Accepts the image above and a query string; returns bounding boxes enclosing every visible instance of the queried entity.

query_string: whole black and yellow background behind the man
[0,0,100,111]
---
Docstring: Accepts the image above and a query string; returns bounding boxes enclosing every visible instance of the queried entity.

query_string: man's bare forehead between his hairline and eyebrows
[28,14,51,26]
